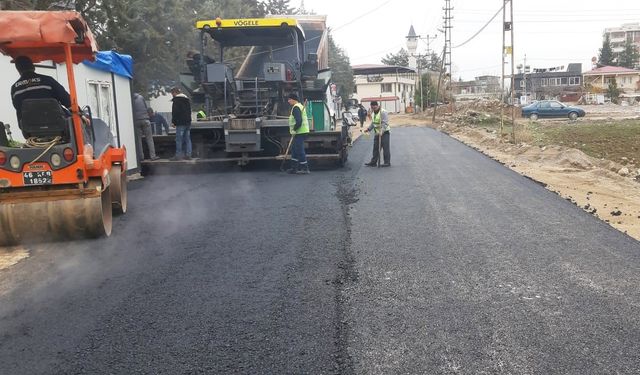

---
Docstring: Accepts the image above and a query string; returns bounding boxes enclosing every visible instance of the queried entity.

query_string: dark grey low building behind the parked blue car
[514,63,583,103]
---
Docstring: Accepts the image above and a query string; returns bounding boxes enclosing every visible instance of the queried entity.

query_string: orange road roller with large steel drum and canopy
[0,11,127,246]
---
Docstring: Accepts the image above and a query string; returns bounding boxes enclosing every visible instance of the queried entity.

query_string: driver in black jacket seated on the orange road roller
[11,56,71,134]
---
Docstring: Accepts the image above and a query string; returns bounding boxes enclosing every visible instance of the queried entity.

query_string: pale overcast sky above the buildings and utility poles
[300,0,640,80]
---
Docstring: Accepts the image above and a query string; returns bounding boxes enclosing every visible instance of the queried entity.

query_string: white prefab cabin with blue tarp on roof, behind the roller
[0,52,139,172]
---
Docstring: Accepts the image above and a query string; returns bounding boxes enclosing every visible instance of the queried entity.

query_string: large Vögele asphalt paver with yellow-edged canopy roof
[143,15,350,172]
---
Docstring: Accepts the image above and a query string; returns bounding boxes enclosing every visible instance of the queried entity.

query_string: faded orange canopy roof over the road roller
[0,11,98,64]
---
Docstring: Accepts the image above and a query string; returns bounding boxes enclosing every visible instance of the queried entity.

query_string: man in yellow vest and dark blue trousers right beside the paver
[287,94,309,174]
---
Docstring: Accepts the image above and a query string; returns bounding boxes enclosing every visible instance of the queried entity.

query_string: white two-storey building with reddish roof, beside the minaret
[352,64,417,113]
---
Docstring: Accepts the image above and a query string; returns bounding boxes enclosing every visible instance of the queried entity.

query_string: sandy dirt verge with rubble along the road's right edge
[391,108,640,240]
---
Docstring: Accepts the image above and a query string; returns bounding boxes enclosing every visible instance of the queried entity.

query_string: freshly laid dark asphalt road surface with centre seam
[0,128,640,374]
